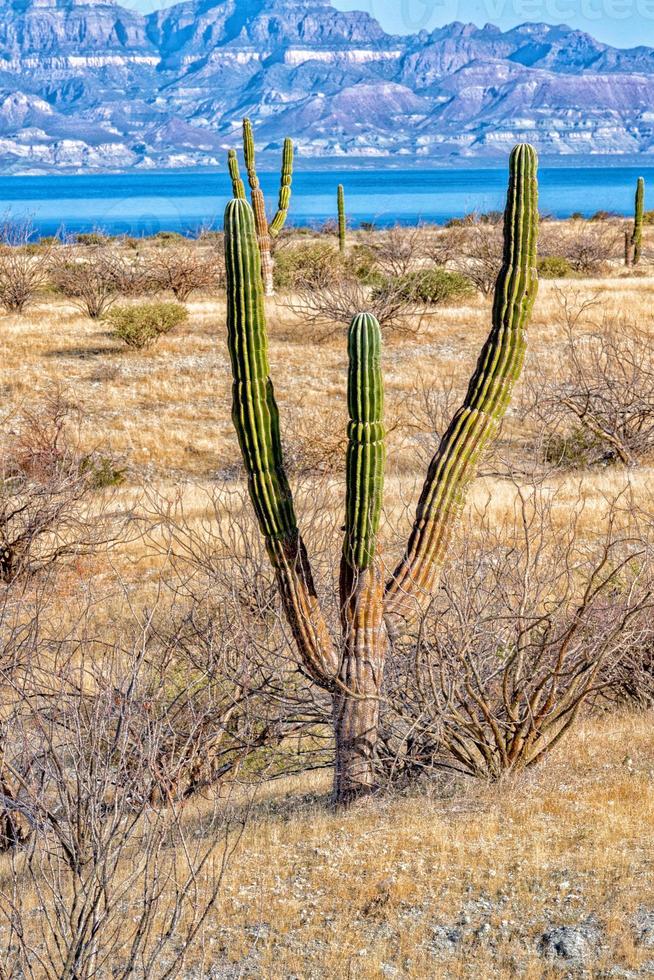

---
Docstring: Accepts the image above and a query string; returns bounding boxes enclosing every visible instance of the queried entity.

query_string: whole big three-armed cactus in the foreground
[225,145,538,802]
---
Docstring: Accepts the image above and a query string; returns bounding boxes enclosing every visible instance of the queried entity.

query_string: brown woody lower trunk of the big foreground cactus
[333,563,387,805]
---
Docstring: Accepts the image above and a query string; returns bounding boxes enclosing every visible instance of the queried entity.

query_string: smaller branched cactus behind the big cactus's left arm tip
[228,119,293,296]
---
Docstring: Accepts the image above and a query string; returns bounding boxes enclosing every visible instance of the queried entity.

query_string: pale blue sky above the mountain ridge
[333,0,654,47]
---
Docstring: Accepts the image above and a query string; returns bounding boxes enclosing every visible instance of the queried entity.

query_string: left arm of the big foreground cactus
[225,199,338,690]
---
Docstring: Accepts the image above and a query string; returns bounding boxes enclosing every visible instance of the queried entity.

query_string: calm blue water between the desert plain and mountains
[0,167,654,235]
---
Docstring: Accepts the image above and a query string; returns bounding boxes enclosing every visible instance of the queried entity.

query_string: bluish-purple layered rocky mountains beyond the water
[0,0,654,174]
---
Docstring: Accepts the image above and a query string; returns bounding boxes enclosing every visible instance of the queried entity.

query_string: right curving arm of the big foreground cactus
[385,144,538,632]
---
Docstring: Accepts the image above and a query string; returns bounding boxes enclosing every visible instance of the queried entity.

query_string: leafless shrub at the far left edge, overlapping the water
[0,219,54,313]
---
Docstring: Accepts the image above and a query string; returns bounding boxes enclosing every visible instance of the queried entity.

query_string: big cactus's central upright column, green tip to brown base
[334,313,386,802]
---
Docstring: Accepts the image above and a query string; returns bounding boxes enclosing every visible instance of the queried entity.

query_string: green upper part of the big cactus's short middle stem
[343,313,386,571]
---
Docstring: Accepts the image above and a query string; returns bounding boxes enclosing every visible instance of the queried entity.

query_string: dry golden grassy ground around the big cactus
[0,218,654,980]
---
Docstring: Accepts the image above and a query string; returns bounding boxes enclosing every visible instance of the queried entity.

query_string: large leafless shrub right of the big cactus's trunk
[382,487,653,779]
